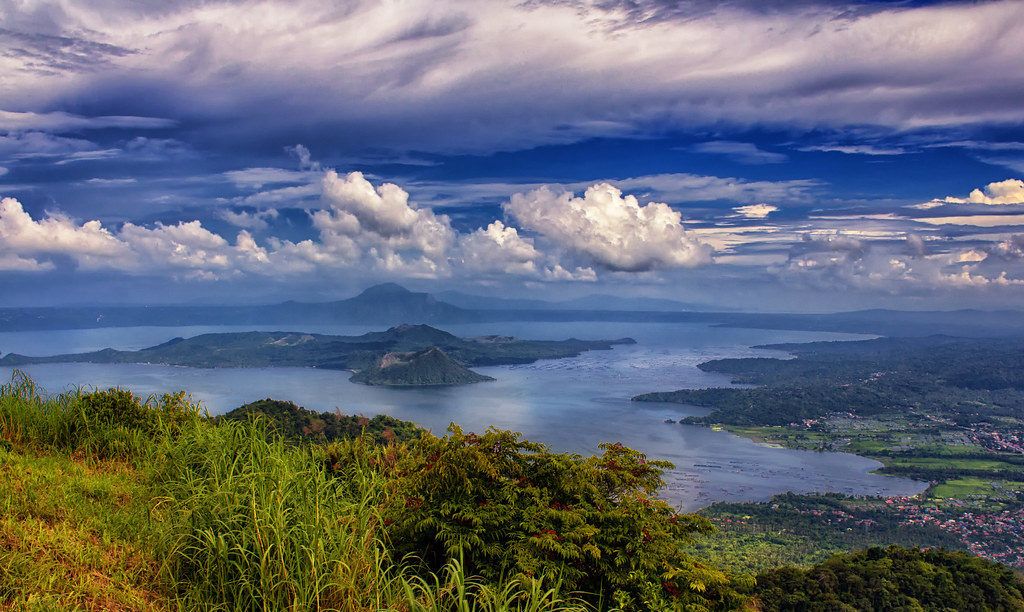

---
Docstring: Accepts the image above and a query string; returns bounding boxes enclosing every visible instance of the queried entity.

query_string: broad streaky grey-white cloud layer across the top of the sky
[0,0,1024,152]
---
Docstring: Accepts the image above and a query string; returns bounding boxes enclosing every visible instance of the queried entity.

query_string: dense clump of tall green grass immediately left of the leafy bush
[152,415,401,610]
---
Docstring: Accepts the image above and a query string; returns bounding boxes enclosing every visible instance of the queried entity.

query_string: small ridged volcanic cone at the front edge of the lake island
[352,347,495,387]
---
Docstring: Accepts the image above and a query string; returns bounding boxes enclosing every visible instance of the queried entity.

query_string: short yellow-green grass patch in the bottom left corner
[0,449,168,610]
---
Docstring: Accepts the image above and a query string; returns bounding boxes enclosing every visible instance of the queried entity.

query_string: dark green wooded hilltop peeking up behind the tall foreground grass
[217,397,423,443]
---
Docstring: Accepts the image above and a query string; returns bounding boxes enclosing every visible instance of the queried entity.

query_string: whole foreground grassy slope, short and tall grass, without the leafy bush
[0,380,584,612]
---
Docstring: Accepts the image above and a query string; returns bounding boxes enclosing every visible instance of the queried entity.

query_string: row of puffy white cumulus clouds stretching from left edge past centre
[0,170,712,281]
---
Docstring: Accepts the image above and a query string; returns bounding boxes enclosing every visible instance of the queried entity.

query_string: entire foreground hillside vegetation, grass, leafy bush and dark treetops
[0,376,1021,611]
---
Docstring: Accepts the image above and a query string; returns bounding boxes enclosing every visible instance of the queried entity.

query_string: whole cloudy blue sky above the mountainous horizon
[0,0,1024,311]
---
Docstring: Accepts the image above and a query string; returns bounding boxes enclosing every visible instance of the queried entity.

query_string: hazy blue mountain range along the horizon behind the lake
[0,282,1024,339]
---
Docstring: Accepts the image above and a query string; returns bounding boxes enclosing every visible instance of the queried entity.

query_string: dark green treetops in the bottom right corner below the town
[756,547,1024,612]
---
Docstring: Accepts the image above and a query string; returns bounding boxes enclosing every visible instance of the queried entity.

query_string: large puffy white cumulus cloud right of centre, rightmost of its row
[505,183,711,271]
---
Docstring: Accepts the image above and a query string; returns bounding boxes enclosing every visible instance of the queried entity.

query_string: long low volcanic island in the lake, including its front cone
[0,324,636,387]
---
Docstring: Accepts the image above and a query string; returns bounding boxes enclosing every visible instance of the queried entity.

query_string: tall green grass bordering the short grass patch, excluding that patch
[0,374,598,612]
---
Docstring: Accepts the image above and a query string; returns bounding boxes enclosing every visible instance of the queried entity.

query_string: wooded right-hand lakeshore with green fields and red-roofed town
[636,336,1024,568]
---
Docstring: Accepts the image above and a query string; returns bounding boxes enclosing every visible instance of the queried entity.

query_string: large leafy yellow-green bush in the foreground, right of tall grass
[327,426,739,609]
